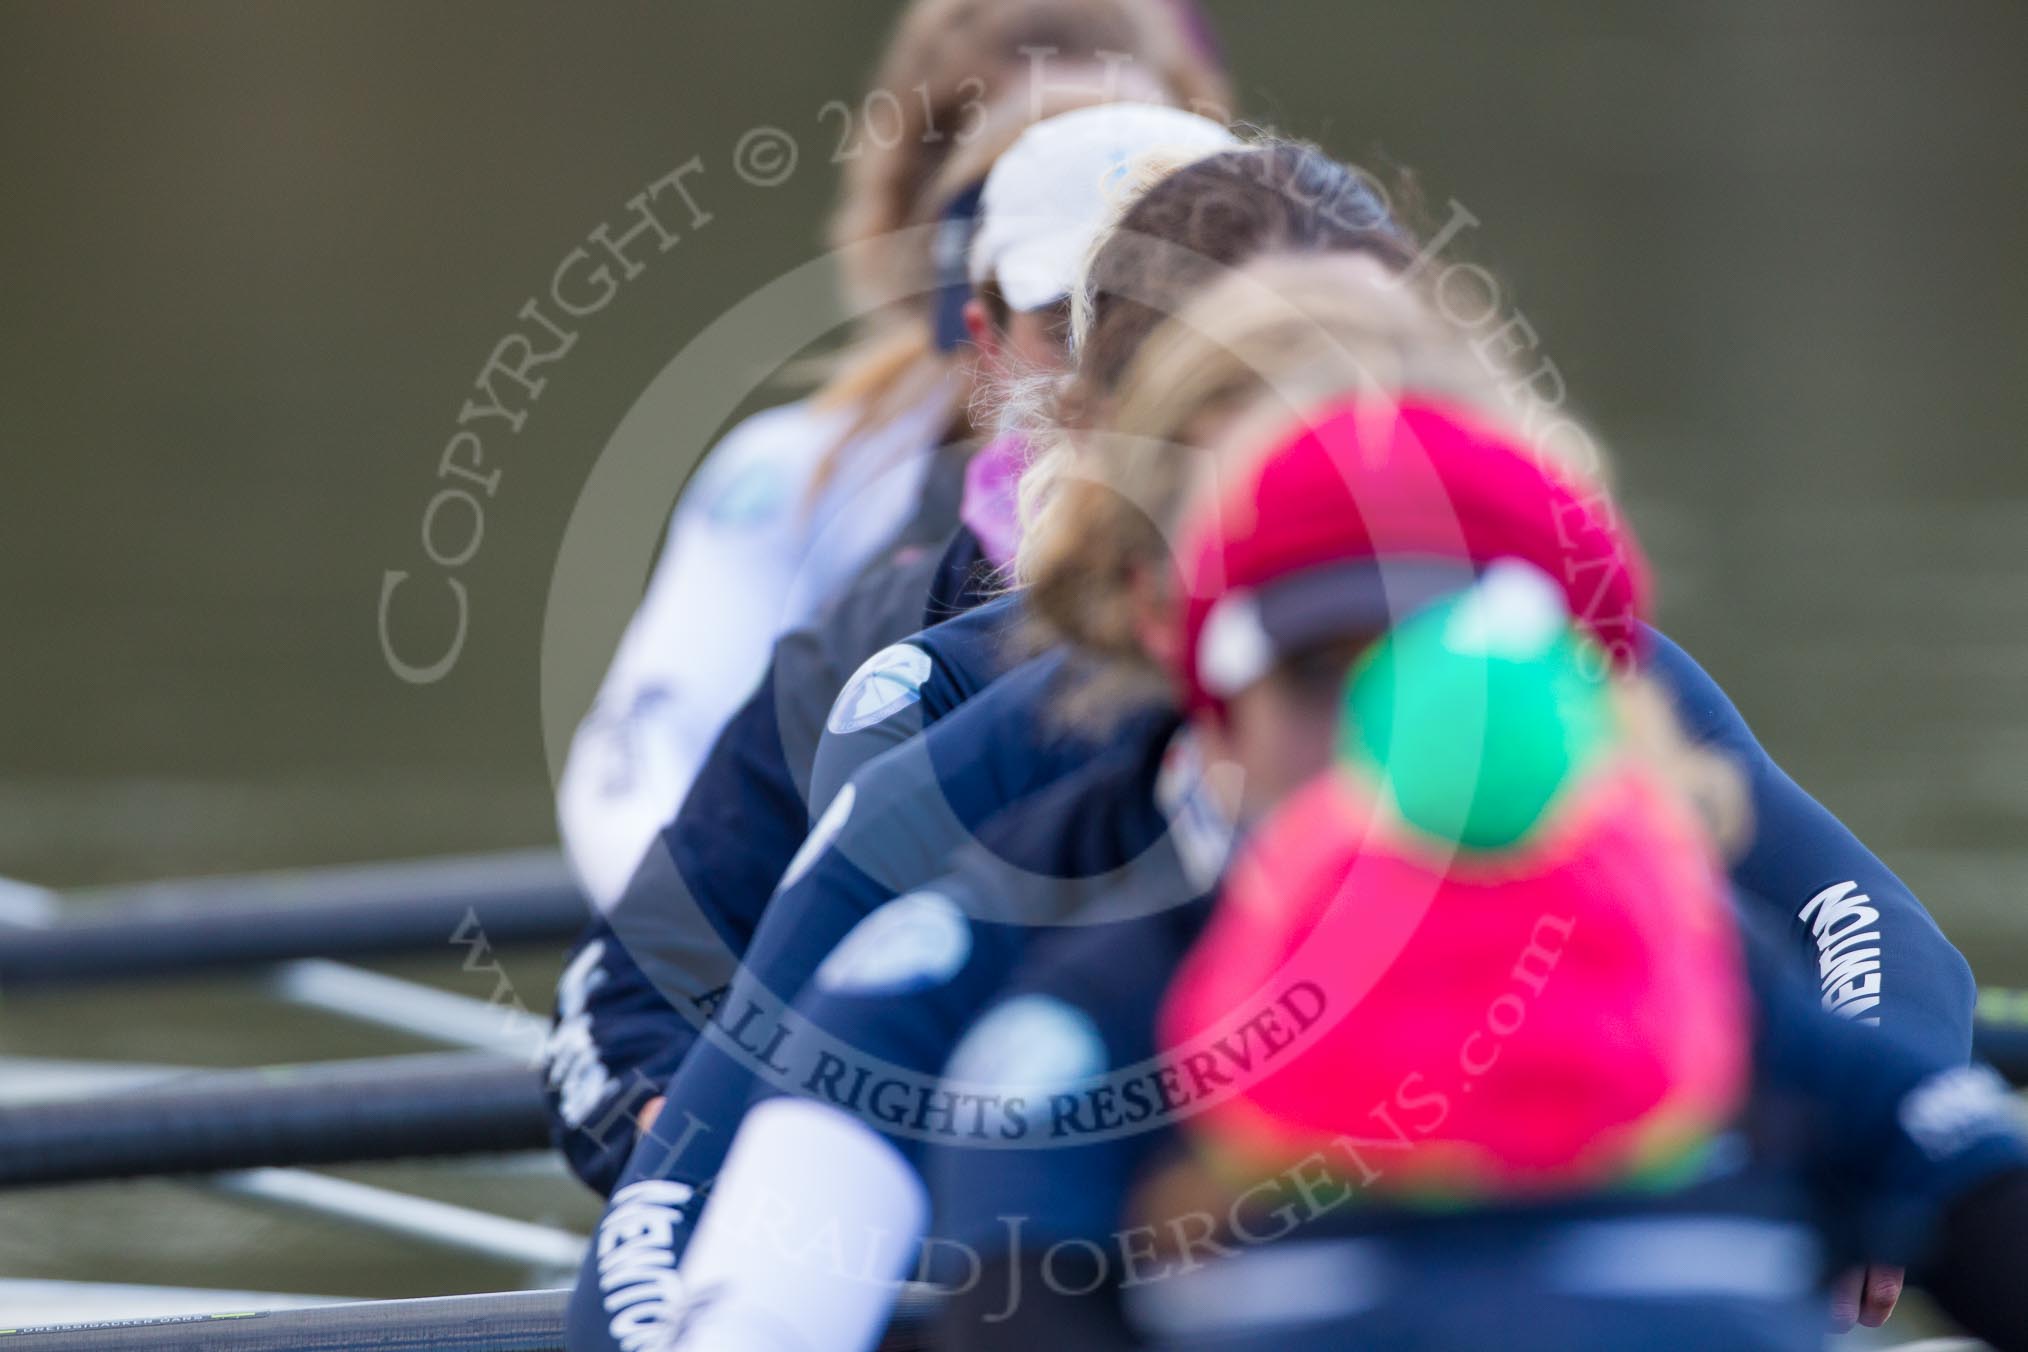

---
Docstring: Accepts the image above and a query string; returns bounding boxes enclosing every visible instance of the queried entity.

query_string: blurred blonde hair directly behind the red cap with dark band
[1018,251,1573,716]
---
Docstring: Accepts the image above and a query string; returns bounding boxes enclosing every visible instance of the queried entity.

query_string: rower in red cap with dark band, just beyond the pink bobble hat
[653,379,1662,1348]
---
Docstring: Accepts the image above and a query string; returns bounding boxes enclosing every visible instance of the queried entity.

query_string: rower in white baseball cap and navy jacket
[546,100,1235,1192]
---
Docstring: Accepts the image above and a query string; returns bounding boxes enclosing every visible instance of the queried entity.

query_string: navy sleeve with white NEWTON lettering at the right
[1651,632,1977,1062]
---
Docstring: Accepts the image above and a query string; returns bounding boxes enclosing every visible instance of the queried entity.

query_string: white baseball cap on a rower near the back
[971,103,1239,310]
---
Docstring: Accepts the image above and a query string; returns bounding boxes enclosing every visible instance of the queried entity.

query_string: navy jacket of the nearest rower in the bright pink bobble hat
[929,900,2028,1352]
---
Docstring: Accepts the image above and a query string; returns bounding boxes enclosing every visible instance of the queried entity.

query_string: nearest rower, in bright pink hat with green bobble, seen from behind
[935,578,2028,1352]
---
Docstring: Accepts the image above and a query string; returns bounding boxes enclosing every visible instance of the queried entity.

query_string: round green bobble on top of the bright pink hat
[1341,561,1616,849]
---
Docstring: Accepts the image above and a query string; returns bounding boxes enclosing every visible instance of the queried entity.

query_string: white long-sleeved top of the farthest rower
[558,389,951,910]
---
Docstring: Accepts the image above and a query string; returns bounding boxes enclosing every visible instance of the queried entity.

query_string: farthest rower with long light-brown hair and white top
[558,0,1231,910]
